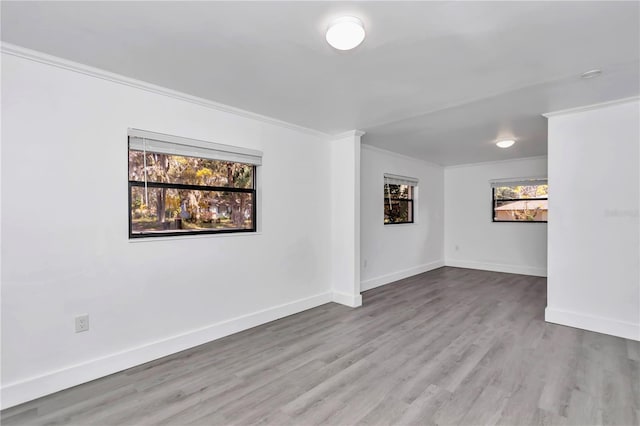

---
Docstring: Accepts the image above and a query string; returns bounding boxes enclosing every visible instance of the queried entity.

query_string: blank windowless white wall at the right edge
[546,99,640,340]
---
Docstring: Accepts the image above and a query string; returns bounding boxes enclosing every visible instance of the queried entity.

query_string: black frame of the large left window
[127,138,258,239]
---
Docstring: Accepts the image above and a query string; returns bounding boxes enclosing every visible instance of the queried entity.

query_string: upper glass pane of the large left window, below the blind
[129,150,254,189]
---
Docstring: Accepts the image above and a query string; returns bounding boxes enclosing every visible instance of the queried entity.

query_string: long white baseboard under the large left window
[1,292,336,409]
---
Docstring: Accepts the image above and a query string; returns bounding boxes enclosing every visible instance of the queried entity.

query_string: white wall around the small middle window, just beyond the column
[360,145,444,291]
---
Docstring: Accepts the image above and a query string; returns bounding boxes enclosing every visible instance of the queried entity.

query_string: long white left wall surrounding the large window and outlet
[2,53,338,407]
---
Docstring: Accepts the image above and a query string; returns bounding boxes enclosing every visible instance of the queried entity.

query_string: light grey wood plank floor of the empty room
[1,267,640,426]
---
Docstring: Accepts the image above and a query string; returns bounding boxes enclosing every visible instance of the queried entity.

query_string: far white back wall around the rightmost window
[444,156,547,276]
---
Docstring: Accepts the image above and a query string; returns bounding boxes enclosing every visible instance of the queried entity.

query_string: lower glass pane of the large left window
[131,186,254,235]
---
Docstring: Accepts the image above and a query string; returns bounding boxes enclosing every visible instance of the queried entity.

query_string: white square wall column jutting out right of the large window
[330,130,364,307]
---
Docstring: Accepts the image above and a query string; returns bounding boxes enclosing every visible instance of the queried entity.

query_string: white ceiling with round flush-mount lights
[2,1,640,165]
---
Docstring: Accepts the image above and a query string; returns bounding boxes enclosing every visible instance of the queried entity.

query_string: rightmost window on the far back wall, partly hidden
[491,179,549,222]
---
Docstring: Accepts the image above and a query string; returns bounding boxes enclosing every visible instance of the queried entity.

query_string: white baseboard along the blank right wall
[544,307,640,341]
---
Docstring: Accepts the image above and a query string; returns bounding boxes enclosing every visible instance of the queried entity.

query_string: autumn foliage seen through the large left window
[129,145,256,238]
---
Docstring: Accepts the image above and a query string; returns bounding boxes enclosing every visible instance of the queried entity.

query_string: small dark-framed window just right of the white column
[384,173,418,225]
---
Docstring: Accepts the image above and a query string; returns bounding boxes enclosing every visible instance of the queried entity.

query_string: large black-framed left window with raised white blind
[129,129,261,238]
